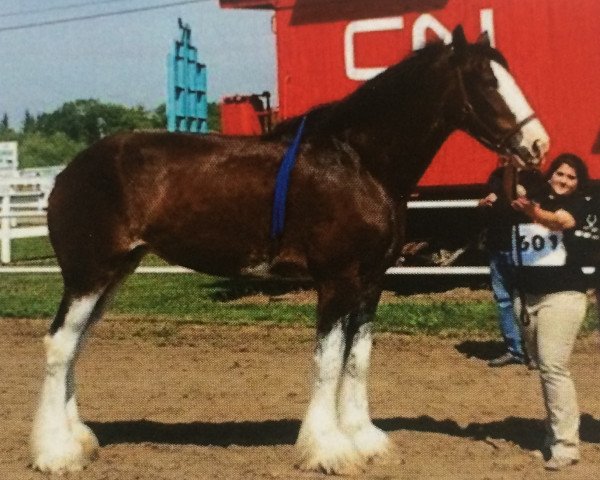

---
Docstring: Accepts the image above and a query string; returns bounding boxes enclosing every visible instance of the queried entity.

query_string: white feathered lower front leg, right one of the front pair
[339,322,390,460]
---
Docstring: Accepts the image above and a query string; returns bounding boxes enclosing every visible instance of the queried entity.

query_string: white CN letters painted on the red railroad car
[344,8,495,81]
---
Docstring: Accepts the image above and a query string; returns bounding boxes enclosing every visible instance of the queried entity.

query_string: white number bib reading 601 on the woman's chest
[512,223,567,267]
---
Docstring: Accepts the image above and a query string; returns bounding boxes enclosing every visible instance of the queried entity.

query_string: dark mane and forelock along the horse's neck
[263,40,508,140]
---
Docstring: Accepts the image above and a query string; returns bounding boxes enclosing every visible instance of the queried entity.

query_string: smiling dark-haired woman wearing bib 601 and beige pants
[512,154,588,470]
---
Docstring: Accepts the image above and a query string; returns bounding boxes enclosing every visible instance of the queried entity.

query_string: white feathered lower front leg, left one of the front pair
[296,321,362,474]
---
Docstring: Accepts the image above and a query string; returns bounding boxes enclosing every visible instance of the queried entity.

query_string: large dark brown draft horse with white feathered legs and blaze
[31,26,549,474]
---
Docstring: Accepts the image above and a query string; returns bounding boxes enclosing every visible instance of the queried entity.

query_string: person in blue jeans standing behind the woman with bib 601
[479,158,543,368]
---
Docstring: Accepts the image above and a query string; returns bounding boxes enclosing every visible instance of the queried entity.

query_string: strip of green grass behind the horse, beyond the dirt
[0,274,598,336]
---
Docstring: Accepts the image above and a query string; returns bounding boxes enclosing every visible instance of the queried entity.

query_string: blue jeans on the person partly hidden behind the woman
[490,251,524,358]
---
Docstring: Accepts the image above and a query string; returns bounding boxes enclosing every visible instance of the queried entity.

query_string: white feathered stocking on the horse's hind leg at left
[31,294,100,472]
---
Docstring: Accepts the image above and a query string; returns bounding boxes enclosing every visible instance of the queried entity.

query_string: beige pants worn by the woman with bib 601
[515,291,587,460]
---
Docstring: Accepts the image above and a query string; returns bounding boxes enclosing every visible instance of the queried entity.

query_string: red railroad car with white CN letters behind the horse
[220,0,600,270]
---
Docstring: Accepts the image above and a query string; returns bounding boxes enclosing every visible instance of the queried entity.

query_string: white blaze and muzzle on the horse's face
[490,60,550,157]
